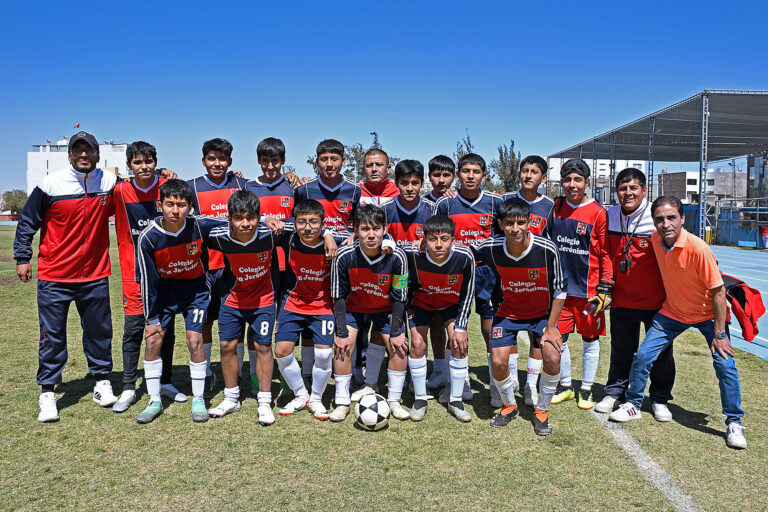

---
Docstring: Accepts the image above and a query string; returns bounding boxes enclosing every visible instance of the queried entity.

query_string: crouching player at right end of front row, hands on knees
[476,198,568,436]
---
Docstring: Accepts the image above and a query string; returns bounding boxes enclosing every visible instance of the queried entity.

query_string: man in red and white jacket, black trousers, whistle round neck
[595,168,675,421]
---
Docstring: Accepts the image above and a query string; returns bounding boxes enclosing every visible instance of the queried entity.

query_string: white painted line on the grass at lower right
[590,409,703,512]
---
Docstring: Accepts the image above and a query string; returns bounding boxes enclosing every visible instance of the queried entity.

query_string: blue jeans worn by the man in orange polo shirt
[625,313,744,424]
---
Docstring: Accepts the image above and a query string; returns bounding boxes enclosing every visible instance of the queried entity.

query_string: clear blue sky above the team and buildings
[0,1,768,191]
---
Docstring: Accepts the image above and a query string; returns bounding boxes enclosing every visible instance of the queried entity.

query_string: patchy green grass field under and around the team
[0,226,768,511]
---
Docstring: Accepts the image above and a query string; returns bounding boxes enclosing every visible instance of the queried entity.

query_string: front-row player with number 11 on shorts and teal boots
[136,180,226,423]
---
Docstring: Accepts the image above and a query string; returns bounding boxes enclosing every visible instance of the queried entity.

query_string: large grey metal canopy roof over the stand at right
[549,90,768,162]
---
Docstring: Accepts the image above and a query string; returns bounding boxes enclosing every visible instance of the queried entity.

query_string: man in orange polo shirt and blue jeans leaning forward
[609,196,747,448]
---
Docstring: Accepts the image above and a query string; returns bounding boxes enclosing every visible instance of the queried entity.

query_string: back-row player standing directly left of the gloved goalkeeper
[504,155,555,405]
